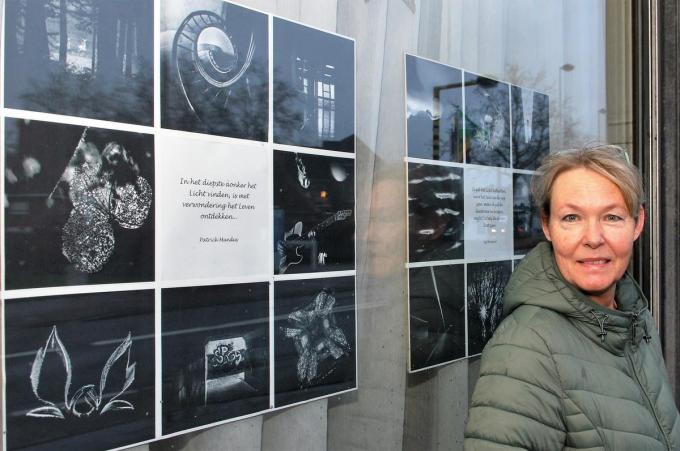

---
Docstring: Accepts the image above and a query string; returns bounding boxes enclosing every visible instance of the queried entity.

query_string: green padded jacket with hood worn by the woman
[465,243,680,451]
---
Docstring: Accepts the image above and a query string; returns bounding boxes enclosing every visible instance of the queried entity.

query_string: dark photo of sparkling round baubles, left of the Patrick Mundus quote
[4,118,154,290]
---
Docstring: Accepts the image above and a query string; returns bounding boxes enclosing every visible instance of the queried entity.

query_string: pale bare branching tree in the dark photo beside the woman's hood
[467,262,510,342]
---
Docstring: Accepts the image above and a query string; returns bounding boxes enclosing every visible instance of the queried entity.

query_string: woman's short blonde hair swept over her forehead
[531,145,644,219]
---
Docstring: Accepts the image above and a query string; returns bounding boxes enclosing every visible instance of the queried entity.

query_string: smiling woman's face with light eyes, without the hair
[542,168,645,307]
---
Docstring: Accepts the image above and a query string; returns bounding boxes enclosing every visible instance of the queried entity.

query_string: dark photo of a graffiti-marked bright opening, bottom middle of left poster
[161,282,270,434]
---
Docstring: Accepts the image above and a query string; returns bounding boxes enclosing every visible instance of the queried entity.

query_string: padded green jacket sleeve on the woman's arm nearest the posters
[465,315,566,451]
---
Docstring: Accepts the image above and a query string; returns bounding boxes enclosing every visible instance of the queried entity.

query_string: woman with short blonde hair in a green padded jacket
[465,146,680,451]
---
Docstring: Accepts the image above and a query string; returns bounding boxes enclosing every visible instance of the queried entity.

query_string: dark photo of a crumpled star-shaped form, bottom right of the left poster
[274,277,356,407]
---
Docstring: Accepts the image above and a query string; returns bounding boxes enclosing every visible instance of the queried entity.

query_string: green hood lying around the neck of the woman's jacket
[503,242,651,355]
